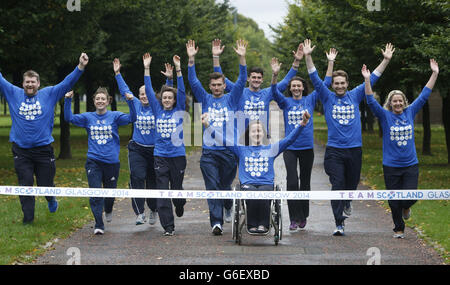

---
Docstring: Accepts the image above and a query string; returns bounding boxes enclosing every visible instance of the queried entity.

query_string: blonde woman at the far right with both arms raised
[361,59,439,238]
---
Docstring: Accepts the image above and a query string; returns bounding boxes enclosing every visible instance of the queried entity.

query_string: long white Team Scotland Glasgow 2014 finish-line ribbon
[0,186,450,200]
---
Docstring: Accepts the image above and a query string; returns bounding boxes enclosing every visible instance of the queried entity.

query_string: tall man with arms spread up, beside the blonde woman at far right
[303,39,394,236]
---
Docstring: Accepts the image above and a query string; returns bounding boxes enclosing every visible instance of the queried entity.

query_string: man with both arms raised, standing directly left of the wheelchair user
[186,40,247,235]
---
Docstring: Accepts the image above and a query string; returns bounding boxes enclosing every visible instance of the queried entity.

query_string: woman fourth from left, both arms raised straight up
[142,53,186,236]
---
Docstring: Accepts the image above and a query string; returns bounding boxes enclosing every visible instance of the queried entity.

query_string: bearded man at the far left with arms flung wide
[0,53,89,224]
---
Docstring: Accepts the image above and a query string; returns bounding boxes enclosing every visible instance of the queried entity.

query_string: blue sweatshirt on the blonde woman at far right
[367,87,431,167]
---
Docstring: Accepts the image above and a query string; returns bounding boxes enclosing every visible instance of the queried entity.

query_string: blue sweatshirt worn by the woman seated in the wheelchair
[229,122,309,185]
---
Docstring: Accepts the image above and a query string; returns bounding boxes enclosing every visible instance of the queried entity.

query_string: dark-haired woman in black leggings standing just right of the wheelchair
[273,47,337,231]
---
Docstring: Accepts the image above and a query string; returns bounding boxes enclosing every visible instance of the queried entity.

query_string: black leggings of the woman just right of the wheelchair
[283,149,314,222]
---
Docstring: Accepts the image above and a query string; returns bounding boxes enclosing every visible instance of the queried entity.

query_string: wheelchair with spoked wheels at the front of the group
[231,184,283,245]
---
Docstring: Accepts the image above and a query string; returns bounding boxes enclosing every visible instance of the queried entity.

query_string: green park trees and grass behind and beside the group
[0,0,450,264]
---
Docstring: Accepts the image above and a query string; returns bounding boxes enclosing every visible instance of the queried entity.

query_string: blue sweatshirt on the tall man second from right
[309,69,380,148]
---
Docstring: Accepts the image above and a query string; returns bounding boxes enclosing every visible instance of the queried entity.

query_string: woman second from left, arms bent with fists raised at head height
[64,87,136,235]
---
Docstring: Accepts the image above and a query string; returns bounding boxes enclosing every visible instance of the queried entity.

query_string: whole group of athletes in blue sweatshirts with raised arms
[0,39,439,238]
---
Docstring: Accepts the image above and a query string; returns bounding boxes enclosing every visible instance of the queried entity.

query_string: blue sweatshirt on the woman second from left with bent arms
[64,98,136,163]
